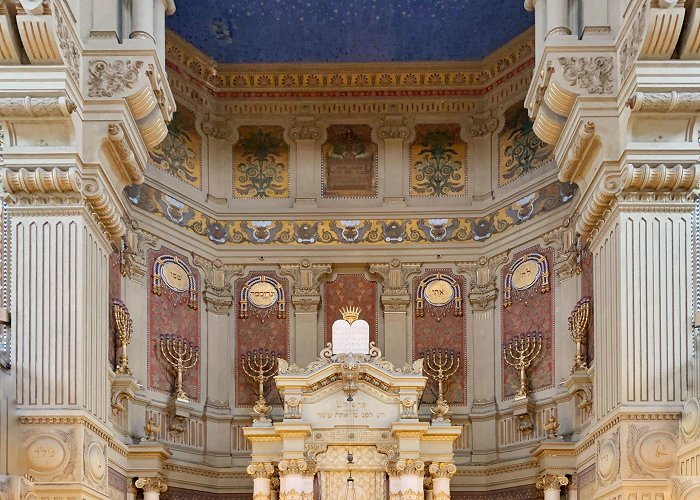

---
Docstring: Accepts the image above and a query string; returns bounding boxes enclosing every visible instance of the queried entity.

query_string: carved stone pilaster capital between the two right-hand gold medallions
[457,252,508,311]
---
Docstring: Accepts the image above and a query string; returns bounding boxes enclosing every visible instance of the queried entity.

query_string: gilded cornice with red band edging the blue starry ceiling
[166,30,535,99]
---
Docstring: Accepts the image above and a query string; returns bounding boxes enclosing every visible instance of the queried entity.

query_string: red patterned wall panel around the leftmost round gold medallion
[147,247,201,401]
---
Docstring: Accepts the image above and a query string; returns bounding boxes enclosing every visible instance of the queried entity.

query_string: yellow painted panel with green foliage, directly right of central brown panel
[409,124,467,196]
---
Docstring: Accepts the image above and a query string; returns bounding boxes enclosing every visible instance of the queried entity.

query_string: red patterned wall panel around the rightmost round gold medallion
[501,247,556,398]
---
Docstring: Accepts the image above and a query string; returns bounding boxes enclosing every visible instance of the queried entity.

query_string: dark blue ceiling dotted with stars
[167,0,534,63]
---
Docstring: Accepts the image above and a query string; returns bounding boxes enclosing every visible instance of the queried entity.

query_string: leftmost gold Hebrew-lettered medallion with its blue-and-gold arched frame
[152,255,197,309]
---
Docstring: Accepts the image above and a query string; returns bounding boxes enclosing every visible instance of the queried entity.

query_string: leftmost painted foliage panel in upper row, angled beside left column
[151,107,202,189]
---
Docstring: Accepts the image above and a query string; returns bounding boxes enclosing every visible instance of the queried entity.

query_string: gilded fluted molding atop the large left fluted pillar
[0,167,126,240]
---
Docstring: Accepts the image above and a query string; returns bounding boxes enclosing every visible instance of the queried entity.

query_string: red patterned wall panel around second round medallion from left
[234,272,289,407]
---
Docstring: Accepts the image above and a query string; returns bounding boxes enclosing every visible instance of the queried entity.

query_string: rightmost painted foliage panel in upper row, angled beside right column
[498,102,554,186]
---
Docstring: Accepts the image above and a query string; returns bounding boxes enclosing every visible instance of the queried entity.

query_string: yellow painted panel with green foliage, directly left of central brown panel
[233,126,289,198]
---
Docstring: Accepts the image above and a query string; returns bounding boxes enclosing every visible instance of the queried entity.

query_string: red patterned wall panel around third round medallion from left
[412,269,467,405]
